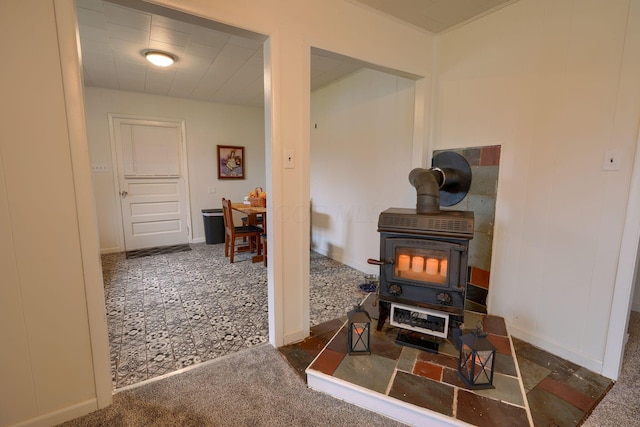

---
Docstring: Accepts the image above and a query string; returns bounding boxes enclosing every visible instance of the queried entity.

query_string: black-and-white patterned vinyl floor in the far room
[102,243,365,389]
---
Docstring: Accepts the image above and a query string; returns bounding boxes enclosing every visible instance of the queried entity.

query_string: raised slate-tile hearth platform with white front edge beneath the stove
[306,300,532,427]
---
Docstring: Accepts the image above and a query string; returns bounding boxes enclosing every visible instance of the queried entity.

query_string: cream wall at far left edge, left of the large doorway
[0,0,110,426]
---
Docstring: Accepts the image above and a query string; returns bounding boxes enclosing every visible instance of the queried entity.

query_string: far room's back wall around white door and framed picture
[85,87,265,252]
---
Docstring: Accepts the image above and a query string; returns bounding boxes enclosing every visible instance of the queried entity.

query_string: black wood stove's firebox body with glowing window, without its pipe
[369,208,474,333]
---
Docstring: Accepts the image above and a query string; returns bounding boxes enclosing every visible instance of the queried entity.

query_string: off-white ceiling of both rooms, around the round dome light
[76,0,514,106]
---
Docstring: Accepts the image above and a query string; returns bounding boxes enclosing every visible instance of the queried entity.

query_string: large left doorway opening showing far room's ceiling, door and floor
[76,0,269,389]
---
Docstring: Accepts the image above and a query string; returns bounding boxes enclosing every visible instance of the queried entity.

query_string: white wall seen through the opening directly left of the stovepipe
[310,70,416,274]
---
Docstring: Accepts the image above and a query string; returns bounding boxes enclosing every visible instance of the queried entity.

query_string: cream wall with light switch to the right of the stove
[434,0,640,372]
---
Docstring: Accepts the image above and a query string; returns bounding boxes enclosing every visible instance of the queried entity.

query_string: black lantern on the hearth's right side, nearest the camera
[458,328,496,389]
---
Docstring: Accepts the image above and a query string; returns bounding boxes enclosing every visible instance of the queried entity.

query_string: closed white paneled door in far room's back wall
[113,117,189,251]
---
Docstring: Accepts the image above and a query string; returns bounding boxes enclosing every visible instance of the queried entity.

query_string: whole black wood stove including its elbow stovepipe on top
[368,153,474,348]
